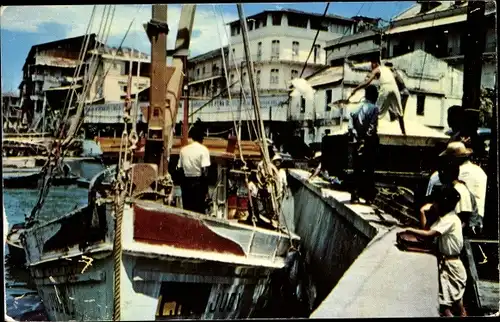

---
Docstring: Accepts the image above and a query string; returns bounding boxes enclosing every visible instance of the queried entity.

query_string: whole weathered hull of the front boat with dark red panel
[23,167,298,321]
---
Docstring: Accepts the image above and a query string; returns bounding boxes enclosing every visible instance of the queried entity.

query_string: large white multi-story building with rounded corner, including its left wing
[178,9,368,140]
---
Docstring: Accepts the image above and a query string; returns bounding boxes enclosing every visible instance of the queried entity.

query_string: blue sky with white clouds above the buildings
[0,1,414,93]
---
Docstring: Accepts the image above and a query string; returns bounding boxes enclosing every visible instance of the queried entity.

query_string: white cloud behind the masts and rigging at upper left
[2,5,237,54]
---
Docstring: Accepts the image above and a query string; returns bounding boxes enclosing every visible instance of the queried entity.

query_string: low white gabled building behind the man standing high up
[290,50,463,144]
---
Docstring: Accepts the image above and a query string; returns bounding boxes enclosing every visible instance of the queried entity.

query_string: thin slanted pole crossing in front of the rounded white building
[236,3,271,164]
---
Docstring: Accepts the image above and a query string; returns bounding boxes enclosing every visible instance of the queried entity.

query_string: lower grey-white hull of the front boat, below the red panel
[31,253,273,321]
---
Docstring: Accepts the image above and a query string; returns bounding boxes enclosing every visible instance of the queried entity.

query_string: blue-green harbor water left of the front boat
[3,185,88,321]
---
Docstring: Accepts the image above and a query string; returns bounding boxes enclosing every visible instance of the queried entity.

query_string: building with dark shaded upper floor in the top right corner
[385,1,497,88]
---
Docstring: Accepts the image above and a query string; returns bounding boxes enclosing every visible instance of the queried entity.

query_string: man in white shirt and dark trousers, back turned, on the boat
[177,126,210,214]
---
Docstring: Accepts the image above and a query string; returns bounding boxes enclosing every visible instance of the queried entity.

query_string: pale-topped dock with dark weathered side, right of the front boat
[288,169,439,318]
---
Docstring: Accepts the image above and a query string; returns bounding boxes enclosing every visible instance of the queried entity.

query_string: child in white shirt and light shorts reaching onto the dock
[408,186,467,316]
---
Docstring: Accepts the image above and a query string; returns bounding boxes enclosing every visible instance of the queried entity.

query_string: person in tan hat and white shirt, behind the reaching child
[427,142,488,234]
